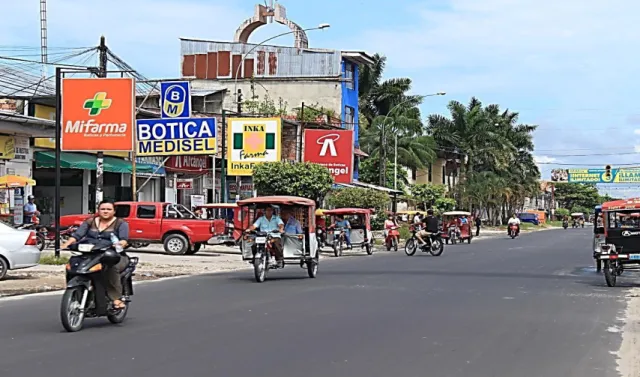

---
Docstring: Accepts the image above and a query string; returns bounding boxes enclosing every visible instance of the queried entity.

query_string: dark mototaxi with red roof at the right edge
[594,198,640,287]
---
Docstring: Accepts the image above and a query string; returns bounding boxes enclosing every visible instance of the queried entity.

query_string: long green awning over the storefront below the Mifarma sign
[35,151,164,175]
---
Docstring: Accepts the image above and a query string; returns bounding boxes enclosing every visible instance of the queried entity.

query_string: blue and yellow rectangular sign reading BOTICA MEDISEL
[136,118,218,156]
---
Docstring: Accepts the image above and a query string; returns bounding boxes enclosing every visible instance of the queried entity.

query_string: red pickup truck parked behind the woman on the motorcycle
[60,202,215,255]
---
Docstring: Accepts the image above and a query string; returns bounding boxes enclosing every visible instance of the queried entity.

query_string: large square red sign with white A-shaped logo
[304,129,353,183]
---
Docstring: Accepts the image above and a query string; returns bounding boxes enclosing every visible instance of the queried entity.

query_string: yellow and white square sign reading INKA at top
[227,118,282,176]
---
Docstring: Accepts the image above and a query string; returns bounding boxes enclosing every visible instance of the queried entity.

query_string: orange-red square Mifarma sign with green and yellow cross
[60,78,135,152]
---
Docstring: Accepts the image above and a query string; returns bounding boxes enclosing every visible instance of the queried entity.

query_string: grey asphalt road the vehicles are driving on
[0,229,629,377]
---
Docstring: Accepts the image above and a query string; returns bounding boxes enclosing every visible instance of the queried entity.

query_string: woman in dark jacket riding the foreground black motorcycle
[61,200,129,309]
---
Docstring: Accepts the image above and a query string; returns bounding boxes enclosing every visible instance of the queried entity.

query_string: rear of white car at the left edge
[0,223,41,280]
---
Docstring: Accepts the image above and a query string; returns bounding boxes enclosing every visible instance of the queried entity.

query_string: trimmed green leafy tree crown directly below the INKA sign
[253,161,333,203]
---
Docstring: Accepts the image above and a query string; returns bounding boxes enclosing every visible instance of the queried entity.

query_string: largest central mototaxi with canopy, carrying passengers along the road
[238,196,319,283]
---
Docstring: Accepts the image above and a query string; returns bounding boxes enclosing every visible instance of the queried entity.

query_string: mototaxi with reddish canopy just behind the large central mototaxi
[324,208,373,257]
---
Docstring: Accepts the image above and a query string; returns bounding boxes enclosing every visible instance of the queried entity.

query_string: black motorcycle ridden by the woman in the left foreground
[60,244,138,332]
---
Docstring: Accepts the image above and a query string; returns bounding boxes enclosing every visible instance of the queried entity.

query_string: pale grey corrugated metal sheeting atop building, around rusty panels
[180,40,342,77]
